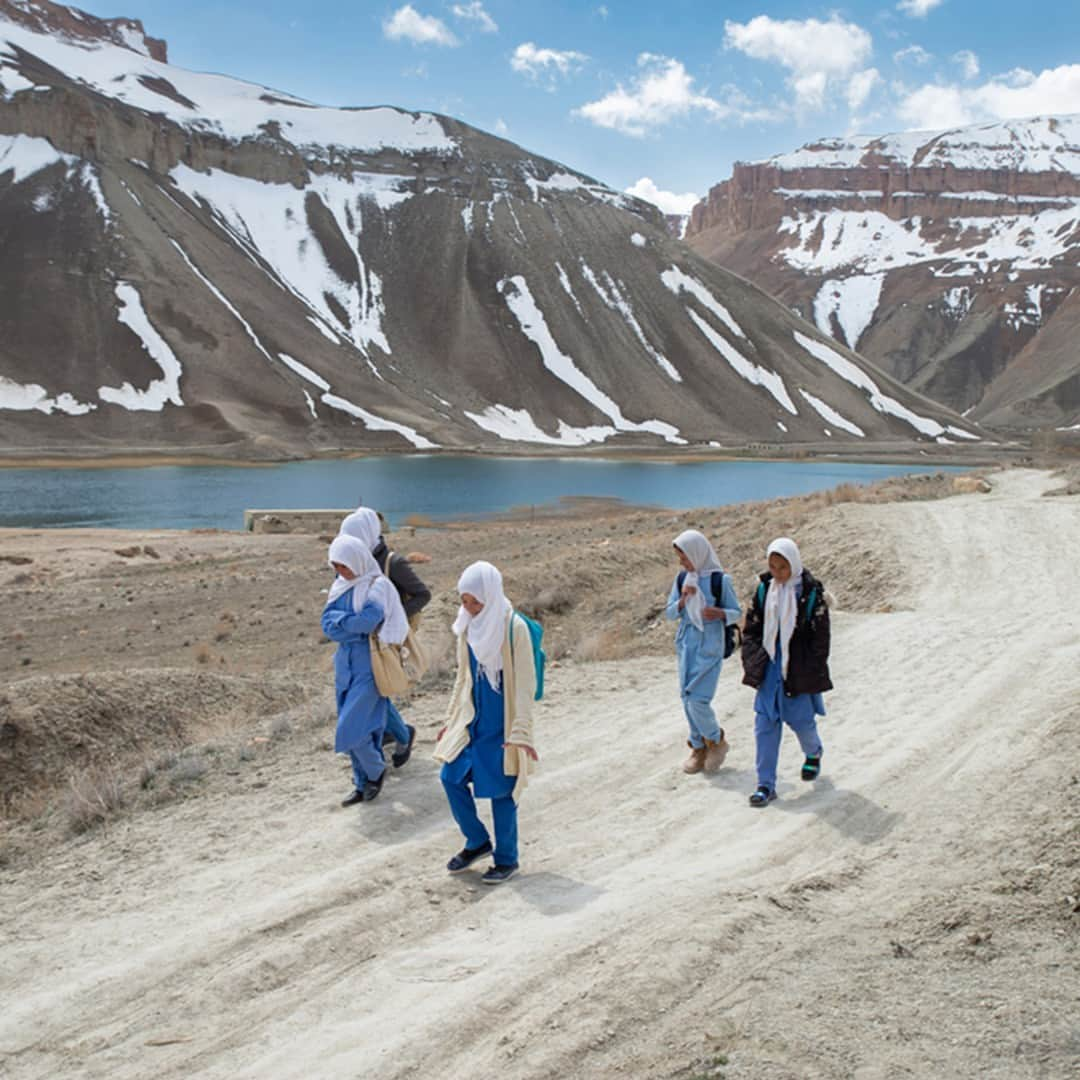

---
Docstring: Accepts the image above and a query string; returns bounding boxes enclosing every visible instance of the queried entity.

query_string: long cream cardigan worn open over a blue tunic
[434,613,537,802]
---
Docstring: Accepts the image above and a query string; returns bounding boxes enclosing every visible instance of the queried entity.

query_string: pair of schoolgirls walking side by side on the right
[666,529,833,807]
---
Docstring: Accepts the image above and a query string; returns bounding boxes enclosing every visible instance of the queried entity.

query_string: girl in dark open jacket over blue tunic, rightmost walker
[742,537,833,807]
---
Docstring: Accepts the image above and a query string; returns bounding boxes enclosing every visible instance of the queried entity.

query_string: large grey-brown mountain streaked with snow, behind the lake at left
[0,0,977,457]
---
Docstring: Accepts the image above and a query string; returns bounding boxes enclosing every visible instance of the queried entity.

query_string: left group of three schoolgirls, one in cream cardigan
[322,508,537,885]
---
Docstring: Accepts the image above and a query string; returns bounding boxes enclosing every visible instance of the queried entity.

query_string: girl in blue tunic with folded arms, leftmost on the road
[322,536,408,806]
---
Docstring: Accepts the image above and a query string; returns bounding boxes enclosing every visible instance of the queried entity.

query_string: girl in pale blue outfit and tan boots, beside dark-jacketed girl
[665,529,742,773]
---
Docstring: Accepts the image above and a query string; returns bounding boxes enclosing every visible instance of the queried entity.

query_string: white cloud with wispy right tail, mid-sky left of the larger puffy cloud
[573,53,775,137]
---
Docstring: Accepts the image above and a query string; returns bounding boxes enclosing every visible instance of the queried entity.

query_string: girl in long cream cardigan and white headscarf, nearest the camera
[435,563,537,885]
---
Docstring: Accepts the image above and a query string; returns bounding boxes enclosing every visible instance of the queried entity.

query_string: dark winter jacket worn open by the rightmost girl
[742,570,833,698]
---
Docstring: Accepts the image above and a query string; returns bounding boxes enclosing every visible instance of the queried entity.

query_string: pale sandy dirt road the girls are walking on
[0,472,1080,1080]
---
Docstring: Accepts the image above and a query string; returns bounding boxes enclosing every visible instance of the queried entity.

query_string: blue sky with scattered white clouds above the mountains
[73,0,1080,210]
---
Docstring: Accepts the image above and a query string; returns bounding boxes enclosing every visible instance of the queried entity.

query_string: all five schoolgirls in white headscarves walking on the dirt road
[322,507,832,885]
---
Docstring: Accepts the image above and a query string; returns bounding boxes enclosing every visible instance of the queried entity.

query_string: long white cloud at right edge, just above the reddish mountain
[897,64,1080,129]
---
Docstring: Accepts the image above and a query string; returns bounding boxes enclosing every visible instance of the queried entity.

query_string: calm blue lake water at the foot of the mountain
[0,455,954,529]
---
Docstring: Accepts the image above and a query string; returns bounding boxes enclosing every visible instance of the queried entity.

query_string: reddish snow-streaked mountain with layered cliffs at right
[687,116,1080,427]
